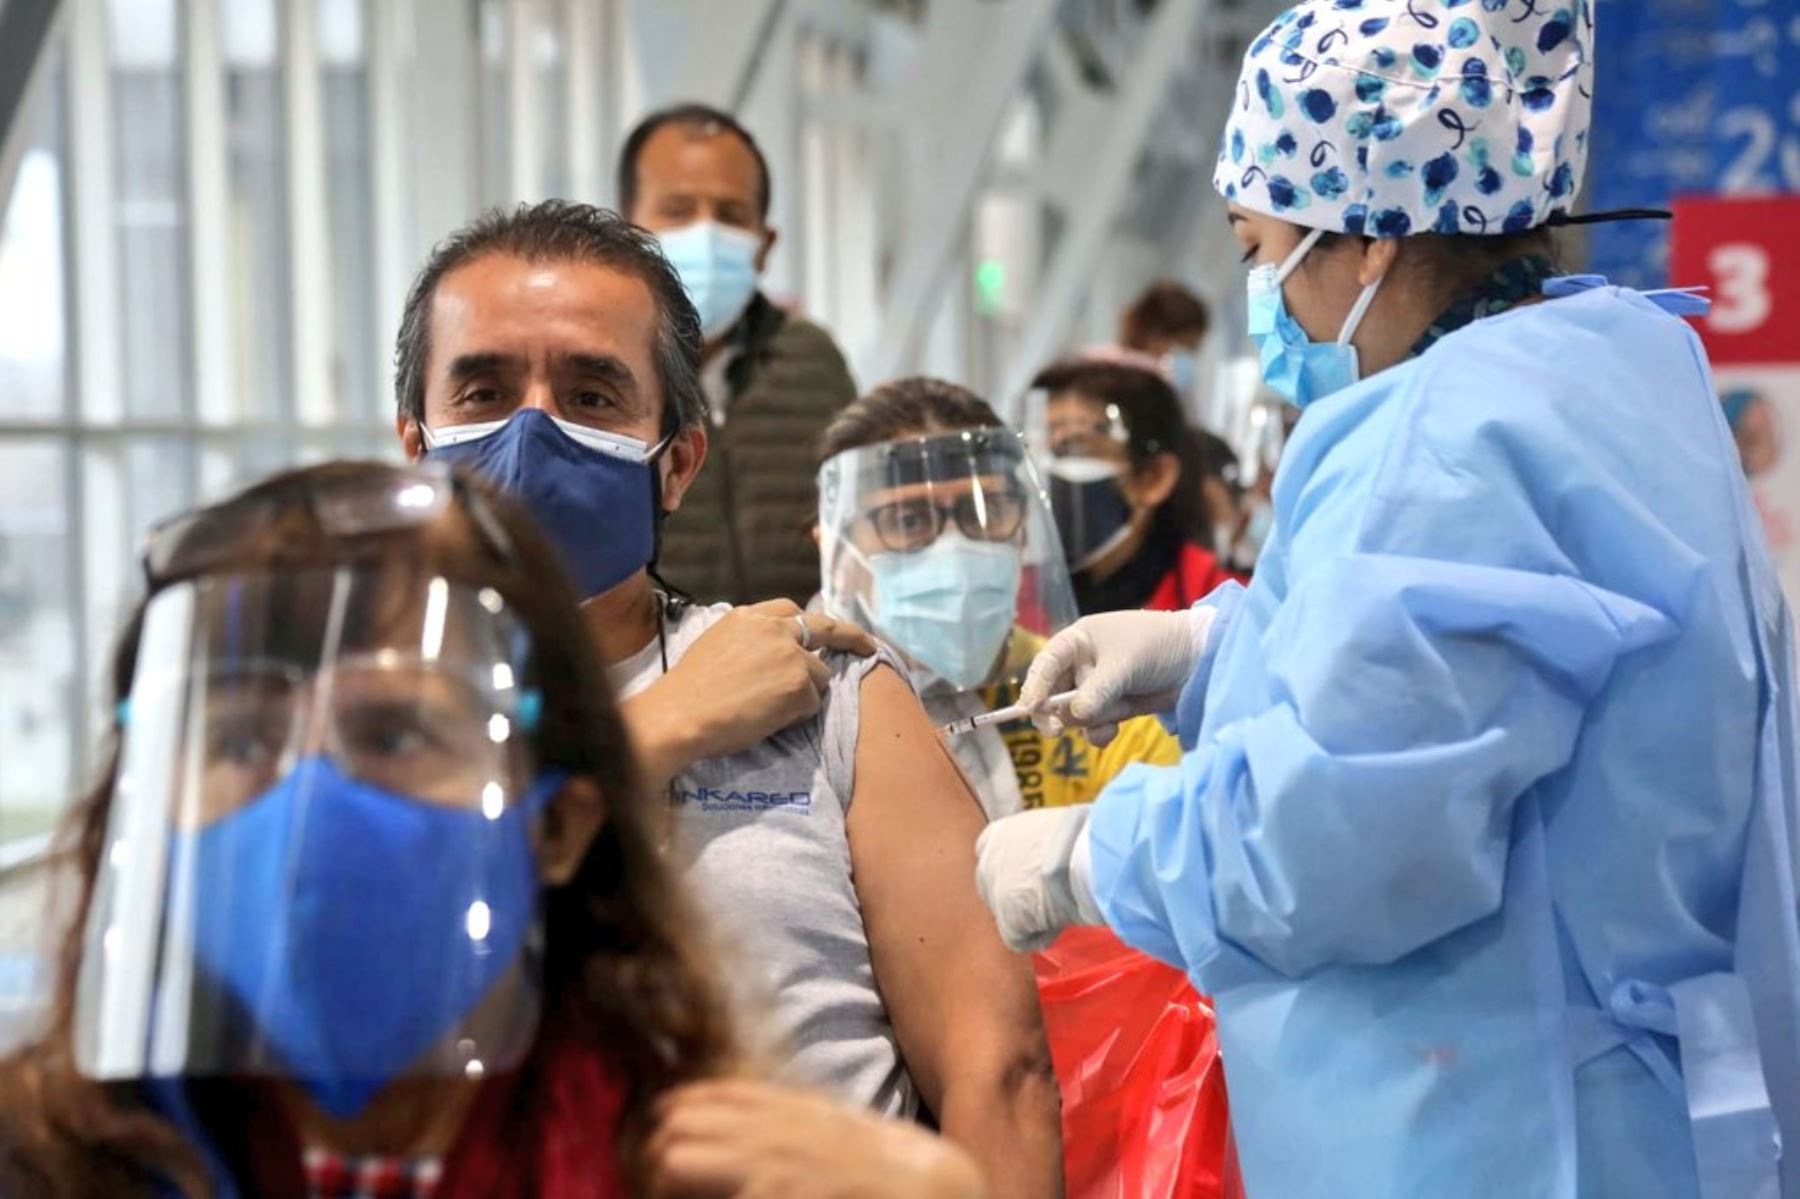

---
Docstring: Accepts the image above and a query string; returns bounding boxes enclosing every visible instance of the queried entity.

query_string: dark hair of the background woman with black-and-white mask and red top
[1031,358,1213,545]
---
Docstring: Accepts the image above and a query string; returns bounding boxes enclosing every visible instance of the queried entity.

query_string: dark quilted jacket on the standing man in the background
[659,295,857,605]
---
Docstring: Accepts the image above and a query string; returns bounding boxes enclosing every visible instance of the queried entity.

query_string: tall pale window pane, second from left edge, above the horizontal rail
[106,0,193,418]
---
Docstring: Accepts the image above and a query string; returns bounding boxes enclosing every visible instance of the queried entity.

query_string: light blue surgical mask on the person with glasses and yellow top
[868,529,1022,688]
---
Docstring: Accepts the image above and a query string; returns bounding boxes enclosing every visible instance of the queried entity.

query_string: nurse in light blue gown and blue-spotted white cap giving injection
[981,0,1800,1199]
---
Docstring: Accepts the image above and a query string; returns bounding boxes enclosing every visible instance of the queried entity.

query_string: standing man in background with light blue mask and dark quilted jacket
[619,104,857,603]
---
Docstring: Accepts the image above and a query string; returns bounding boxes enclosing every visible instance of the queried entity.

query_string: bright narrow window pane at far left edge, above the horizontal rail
[0,49,68,419]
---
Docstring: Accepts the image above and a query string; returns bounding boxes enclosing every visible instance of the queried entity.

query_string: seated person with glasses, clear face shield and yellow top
[819,378,1179,819]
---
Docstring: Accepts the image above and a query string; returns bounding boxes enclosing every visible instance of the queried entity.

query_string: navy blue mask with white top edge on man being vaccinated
[425,409,673,600]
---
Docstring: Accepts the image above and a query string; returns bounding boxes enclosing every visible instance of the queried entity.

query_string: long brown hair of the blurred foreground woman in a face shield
[0,463,736,1195]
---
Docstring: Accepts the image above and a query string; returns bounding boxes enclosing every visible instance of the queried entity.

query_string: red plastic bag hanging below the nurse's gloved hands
[1033,929,1244,1199]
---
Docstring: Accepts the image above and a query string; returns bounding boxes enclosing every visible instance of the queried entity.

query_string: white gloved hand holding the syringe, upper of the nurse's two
[1019,605,1217,745]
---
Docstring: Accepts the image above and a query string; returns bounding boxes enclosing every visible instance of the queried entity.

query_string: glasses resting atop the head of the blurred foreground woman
[144,463,518,594]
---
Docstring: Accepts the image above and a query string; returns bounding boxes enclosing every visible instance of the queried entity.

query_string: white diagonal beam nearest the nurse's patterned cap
[999,0,1211,416]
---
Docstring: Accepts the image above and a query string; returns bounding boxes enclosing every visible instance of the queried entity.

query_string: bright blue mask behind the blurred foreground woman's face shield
[175,758,562,1120]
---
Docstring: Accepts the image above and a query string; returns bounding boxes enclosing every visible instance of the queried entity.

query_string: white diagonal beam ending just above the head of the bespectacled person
[855,0,1055,382]
